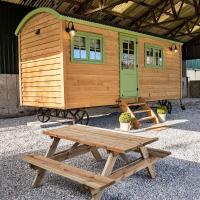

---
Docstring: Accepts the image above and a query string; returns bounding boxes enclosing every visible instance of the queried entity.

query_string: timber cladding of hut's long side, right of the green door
[138,38,182,100]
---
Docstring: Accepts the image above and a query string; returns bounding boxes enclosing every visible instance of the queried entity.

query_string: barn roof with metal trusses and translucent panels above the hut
[1,0,200,42]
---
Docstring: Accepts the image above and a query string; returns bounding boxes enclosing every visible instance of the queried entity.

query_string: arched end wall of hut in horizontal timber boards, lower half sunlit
[20,13,64,108]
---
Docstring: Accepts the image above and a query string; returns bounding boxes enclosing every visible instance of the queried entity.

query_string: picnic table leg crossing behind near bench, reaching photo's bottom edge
[92,152,118,200]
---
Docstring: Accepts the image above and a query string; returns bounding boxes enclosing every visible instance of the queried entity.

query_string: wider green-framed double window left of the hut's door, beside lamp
[71,32,103,64]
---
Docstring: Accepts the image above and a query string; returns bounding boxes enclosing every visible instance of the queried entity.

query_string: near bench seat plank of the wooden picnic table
[23,155,115,190]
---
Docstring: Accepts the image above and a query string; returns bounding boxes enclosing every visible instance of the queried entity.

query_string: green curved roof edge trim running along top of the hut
[15,7,183,45]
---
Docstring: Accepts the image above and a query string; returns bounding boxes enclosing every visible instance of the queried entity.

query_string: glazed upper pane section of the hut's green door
[122,40,134,69]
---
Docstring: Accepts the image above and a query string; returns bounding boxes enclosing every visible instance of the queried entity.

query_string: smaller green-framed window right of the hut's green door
[145,45,163,67]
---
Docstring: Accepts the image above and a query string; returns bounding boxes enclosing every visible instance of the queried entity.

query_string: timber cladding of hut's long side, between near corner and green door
[63,22,119,108]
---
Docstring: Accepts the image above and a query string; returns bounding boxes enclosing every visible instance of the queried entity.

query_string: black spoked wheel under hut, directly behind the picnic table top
[70,109,89,125]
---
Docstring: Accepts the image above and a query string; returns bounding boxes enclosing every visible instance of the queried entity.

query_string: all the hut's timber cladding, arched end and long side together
[19,10,182,109]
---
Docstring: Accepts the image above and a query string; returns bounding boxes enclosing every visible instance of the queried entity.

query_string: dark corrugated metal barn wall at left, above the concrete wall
[0,1,31,74]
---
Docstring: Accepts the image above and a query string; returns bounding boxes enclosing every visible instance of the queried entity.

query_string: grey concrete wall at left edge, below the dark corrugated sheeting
[0,74,32,118]
